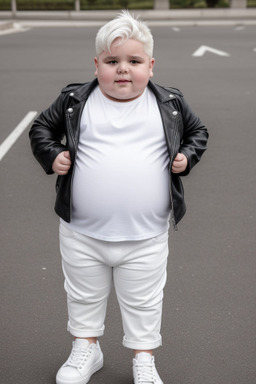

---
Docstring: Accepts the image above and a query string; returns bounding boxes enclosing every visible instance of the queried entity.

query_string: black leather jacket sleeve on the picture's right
[177,97,209,176]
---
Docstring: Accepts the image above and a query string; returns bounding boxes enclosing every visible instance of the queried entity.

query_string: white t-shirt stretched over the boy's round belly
[64,87,170,241]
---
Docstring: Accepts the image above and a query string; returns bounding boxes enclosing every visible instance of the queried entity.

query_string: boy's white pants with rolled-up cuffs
[60,224,168,350]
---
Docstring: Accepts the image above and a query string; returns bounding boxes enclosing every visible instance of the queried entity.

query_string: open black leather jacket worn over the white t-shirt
[29,79,208,227]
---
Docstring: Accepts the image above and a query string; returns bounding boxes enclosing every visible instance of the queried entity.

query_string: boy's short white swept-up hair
[95,10,154,59]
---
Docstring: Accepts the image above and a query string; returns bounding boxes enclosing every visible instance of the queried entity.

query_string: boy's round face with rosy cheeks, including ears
[94,39,155,102]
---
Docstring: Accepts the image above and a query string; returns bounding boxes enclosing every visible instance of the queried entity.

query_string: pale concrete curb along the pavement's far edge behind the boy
[0,8,256,30]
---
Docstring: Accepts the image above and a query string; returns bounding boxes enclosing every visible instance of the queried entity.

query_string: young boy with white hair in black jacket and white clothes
[30,11,208,384]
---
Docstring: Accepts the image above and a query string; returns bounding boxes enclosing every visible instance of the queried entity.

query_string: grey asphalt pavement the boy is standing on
[0,19,256,384]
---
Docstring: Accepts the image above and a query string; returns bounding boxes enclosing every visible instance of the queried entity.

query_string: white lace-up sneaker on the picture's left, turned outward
[56,339,103,384]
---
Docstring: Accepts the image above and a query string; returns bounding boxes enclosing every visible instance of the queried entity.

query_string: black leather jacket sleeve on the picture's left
[29,94,66,175]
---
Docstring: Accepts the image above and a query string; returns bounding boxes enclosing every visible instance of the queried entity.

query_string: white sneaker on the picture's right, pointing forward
[133,352,163,384]
